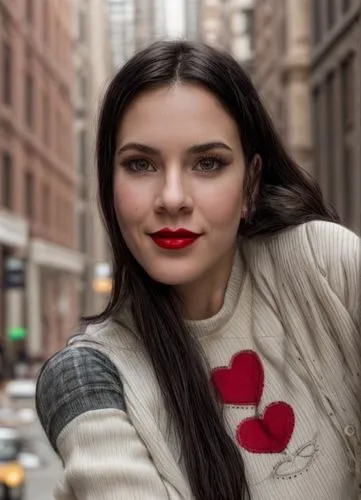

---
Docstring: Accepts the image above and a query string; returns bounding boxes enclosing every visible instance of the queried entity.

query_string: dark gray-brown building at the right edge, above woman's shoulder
[310,0,361,233]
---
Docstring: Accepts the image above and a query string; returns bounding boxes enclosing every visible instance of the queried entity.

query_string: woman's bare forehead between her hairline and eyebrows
[118,84,239,146]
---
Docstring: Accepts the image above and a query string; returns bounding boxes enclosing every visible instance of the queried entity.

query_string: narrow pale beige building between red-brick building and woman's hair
[73,0,114,316]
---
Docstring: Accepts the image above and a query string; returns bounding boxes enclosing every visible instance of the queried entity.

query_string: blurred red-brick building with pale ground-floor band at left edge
[0,0,83,372]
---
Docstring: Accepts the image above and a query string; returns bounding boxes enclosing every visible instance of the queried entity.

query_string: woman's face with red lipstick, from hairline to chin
[114,84,245,285]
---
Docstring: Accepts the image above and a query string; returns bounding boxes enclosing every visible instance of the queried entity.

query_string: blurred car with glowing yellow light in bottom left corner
[0,427,25,500]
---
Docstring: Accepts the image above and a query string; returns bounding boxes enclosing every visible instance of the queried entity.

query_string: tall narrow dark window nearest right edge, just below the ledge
[341,54,355,129]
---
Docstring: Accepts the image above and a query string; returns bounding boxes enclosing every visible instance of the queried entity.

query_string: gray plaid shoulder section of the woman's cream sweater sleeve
[36,347,125,451]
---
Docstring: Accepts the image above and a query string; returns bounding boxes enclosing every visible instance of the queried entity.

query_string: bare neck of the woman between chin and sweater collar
[176,247,236,321]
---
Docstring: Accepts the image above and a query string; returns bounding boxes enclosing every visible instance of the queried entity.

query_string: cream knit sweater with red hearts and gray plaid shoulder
[37,221,361,500]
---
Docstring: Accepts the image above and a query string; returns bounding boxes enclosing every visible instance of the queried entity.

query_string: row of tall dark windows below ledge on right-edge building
[313,52,356,224]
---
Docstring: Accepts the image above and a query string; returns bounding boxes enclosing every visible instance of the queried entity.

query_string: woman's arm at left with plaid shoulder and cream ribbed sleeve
[36,347,168,500]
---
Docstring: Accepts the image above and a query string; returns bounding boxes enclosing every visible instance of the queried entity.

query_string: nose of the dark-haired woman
[156,168,193,215]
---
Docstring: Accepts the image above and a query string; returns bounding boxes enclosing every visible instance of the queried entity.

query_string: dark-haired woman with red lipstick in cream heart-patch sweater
[37,41,361,500]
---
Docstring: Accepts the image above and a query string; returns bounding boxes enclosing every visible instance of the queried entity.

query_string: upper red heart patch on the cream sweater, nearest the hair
[211,351,264,406]
